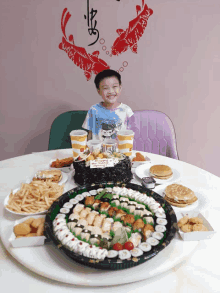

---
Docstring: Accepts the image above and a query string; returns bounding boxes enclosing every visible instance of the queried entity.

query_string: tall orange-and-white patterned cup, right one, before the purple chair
[117,130,134,156]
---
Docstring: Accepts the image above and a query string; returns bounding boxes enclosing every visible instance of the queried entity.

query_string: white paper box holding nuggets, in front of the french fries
[9,215,46,247]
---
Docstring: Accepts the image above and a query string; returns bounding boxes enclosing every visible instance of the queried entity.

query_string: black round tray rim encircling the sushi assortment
[44,182,177,270]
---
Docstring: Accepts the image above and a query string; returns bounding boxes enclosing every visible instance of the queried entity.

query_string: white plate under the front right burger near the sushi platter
[157,181,210,213]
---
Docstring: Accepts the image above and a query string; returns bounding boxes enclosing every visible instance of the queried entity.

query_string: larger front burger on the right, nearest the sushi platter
[164,183,198,207]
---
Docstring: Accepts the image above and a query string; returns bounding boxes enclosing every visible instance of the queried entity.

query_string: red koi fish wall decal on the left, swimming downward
[59,8,110,80]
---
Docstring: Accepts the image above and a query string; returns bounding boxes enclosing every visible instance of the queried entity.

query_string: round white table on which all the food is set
[0,149,220,293]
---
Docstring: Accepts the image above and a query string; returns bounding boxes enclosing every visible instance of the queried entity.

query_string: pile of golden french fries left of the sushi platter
[6,181,64,214]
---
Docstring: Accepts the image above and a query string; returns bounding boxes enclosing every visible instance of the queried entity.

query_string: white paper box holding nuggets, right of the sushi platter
[176,211,216,241]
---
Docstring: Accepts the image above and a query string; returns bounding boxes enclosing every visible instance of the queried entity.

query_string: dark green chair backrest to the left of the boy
[48,111,87,150]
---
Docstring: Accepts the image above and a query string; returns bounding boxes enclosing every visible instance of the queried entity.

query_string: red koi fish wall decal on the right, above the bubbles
[112,0,153,55]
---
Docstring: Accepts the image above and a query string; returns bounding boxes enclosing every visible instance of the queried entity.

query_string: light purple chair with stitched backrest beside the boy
[129,110,179,160]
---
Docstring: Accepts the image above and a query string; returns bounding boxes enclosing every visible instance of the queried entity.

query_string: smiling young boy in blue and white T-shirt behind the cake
[82,69,134,141]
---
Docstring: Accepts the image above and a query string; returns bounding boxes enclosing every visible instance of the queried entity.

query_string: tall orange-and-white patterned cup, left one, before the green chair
[70,130,87,158]
